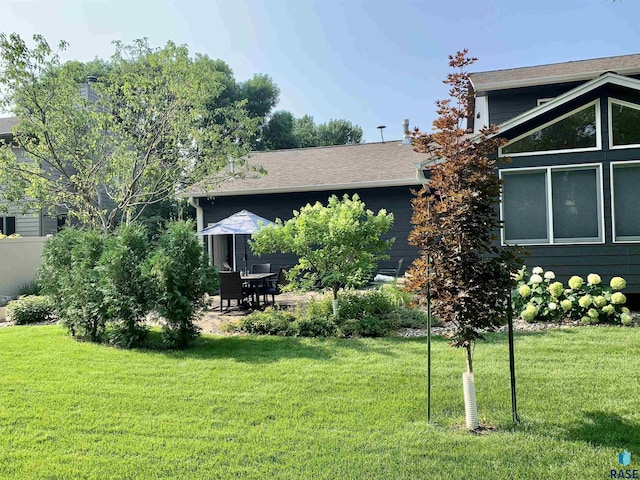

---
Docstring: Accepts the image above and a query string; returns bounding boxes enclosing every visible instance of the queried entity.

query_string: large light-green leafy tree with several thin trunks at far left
[0,34,258,231]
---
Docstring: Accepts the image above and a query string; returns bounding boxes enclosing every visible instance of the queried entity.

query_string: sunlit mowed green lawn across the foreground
[0,326,640,479]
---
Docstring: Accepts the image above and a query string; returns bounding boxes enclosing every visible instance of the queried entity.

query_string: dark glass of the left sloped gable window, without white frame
[502,105,597,154]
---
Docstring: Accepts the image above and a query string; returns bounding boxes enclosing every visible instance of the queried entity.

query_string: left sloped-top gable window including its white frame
[500,101,600,157]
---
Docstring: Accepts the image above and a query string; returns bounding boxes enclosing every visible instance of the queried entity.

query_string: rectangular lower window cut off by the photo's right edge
[613,165,640,240]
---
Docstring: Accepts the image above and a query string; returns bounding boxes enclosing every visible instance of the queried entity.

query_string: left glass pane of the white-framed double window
[502,172,549,243]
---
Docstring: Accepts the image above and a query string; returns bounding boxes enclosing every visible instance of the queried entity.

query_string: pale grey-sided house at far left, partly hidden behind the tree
[0,117,64,237]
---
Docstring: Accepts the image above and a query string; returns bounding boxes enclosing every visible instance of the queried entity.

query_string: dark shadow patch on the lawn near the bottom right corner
[566,410,640,452]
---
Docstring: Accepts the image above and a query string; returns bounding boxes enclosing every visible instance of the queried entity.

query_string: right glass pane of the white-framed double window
[551,168,600,240]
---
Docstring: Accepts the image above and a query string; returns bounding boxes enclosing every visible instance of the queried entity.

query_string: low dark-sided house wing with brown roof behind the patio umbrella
[184,125,425,271]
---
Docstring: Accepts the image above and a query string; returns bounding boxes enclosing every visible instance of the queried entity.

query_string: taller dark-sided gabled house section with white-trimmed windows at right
[469,54,640,293]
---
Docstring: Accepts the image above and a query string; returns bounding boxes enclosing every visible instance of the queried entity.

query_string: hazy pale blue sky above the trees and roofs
[0,0,640,142]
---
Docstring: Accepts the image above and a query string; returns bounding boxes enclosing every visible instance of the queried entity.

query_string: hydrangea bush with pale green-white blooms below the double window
[512,267,632,325]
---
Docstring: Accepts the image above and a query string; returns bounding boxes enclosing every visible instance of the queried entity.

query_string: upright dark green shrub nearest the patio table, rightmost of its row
[148,221,218,348]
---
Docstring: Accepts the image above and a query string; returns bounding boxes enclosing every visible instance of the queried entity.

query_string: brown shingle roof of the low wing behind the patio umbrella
[184,141,427,197]
